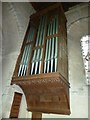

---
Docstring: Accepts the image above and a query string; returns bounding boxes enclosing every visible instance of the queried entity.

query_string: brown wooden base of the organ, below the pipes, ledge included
[12,73,70,114]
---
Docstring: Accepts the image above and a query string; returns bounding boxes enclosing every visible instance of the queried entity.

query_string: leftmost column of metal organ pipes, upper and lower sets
[18,28,35,76]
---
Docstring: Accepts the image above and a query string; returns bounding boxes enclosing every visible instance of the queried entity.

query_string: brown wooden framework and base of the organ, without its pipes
[11,3,70,118]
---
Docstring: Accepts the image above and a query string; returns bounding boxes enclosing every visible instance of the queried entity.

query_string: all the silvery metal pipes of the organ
[18,15,58,76]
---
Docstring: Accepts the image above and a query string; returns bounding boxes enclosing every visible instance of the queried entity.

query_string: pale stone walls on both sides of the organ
[2,3,88,118]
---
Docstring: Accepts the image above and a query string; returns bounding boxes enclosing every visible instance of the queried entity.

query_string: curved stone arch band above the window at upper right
[65,3,90,29]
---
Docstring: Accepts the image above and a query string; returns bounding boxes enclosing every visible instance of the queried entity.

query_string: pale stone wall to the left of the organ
[2,2,35,118]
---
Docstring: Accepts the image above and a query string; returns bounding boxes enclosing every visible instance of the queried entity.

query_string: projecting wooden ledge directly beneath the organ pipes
[11,72,70,87]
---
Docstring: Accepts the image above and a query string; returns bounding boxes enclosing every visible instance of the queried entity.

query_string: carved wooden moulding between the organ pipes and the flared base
[11,72,70,87]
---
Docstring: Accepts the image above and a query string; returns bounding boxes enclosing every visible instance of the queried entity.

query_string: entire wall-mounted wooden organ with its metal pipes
[11,3,70,118]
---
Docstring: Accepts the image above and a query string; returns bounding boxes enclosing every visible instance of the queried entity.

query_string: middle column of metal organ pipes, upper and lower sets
[30,16,46,75]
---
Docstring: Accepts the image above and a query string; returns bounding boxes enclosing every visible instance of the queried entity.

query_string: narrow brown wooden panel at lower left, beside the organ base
[10,92,22,118]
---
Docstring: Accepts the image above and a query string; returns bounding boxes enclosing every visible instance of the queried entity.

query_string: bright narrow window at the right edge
[81,35,90,85]
